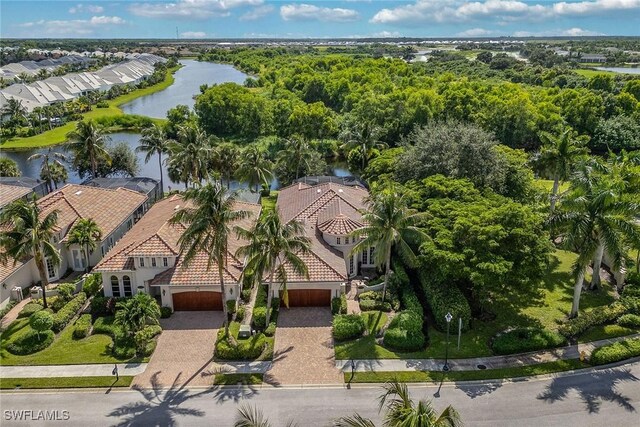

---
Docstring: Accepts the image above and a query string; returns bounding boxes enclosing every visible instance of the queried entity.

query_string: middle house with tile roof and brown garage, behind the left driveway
[94,194,260,311]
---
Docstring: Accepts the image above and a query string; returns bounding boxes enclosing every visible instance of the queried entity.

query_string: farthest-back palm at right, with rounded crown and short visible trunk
[534,127,589,213]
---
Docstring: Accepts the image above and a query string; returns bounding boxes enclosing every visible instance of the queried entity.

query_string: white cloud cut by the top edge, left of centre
[129,0,264,20]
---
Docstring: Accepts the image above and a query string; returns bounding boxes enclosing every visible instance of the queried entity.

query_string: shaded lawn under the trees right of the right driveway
[335,250,614,359]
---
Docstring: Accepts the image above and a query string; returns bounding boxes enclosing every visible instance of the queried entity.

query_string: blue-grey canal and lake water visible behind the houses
[0,60,351,190]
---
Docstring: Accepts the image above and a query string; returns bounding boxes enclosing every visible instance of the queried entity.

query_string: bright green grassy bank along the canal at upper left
[0,66,180,149]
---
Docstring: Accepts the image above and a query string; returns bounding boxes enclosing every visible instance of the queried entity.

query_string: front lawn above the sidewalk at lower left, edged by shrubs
[0,318,146,366]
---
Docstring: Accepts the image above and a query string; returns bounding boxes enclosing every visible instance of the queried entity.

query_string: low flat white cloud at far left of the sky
[18,16,127,37]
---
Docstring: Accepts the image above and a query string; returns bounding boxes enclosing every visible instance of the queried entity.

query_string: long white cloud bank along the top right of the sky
[370,0,640,24]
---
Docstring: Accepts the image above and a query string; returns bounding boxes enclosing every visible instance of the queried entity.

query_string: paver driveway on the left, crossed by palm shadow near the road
[133,311,224,388]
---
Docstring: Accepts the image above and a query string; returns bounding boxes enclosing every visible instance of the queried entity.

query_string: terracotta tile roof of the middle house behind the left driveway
[94,195,260,286]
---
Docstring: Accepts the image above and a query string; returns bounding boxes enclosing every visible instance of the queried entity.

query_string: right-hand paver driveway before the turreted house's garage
[265,307,344,385]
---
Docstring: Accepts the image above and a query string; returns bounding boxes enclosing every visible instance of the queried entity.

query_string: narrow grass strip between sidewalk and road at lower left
[0,376,133,390]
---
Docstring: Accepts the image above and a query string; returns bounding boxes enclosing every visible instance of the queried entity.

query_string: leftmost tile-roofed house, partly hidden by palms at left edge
[0,184,147,306]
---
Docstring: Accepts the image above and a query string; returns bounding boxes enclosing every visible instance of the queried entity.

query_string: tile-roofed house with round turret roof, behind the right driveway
[274,182,375,307]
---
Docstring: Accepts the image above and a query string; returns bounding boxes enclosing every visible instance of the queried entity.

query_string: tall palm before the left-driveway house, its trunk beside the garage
[171,181,250,340]
